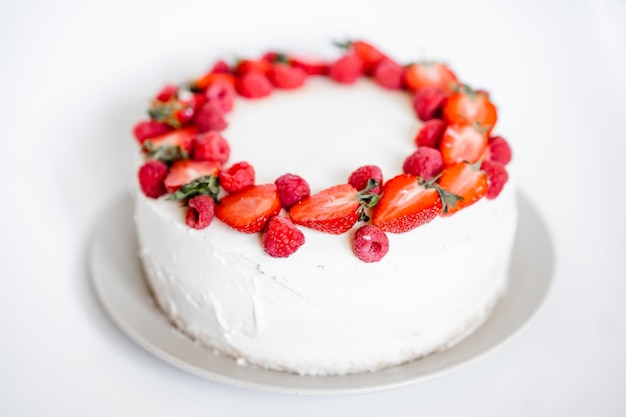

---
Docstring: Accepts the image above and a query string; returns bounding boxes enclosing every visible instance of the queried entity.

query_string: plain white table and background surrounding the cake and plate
[0,0,626,417]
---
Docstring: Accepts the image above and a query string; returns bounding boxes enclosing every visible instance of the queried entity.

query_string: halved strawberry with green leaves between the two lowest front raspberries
[289,181,378,235]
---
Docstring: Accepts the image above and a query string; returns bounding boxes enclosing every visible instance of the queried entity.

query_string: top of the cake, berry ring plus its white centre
[134,41,511,263]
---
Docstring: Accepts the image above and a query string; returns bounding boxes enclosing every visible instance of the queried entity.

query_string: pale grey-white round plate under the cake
[90,194,554,395]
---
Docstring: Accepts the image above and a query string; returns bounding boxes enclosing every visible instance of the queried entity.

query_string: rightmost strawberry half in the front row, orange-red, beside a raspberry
[437,162,488,216]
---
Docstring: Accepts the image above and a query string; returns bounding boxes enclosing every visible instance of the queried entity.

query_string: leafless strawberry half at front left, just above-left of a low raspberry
[215,184,280,233]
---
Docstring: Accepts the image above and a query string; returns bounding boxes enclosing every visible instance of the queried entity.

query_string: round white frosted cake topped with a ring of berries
[134,41,517,375]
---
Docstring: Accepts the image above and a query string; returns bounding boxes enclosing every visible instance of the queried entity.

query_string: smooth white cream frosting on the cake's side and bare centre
[135,79,517,375]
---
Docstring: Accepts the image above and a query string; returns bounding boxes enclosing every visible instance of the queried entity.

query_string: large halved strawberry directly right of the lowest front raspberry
[372,174,442,233]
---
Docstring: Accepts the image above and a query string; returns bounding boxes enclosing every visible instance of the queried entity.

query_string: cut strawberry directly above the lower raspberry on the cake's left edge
[142,127,197,163]
